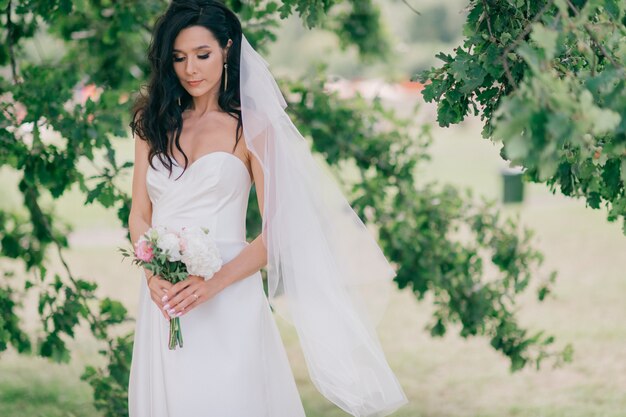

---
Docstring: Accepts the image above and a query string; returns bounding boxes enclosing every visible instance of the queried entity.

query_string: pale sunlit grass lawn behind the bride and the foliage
[0,111,626,417]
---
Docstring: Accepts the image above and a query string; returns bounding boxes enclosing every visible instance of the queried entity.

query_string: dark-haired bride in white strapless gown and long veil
[129,1,407,417]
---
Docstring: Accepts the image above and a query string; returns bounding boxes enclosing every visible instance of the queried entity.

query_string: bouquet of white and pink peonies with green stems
[119,226,222,350]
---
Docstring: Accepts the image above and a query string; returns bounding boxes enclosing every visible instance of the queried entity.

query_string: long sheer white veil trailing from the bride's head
[240,35,407,416]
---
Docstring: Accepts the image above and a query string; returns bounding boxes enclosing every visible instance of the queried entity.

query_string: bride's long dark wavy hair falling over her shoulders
[129,0,242,179]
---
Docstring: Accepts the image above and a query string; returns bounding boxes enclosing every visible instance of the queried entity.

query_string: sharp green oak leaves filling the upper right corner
[419,0,626,234]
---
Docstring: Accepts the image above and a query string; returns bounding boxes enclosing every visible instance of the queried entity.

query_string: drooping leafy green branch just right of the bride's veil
[288,68,571,370]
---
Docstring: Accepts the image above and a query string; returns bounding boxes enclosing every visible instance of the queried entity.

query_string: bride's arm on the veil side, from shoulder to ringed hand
[164,138,267,316]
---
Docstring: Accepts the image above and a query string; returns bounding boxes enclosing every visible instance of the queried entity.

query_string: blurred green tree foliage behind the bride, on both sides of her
[0,0,570,416]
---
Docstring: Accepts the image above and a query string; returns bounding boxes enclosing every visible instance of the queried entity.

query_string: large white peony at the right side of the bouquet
[180,227,222,279]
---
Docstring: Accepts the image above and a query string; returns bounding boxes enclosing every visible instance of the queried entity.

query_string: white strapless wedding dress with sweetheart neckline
[128,151,305,417]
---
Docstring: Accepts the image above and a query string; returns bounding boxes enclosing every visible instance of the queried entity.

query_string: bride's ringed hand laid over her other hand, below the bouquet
[163,275,222,317]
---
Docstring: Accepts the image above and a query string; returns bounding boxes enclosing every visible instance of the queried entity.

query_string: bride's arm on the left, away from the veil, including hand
[128,135,172,319]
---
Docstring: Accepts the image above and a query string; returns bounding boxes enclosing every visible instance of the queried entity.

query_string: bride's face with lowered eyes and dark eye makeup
[172,26,232,97]
